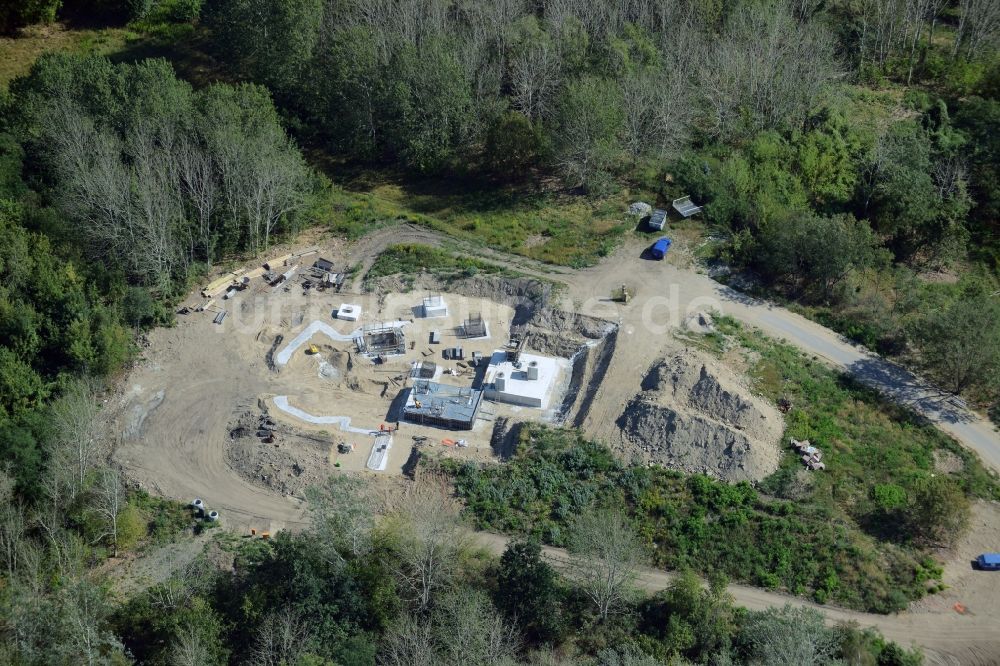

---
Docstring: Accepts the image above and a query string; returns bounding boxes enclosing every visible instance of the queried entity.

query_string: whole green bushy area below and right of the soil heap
[440,318,997,612]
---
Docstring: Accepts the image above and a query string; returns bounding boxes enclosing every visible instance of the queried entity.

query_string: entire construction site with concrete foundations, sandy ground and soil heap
[116,231,796,529]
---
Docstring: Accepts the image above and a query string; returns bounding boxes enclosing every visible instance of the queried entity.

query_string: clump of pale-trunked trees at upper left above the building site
[12,55,310,292]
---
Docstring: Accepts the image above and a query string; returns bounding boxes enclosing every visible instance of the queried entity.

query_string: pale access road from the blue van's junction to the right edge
[558,239,1000,471]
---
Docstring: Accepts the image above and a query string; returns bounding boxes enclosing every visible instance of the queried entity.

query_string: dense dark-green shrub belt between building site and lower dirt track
[441,427,935,612]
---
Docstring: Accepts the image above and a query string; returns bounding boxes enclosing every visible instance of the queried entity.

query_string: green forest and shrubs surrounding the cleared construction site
[0,0,1000,666]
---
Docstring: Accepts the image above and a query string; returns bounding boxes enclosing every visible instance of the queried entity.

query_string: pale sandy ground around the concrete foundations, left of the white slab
[112,233,569,531]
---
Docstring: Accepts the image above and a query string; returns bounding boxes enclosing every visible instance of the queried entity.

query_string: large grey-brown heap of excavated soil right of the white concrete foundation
[617,352,784,482]
